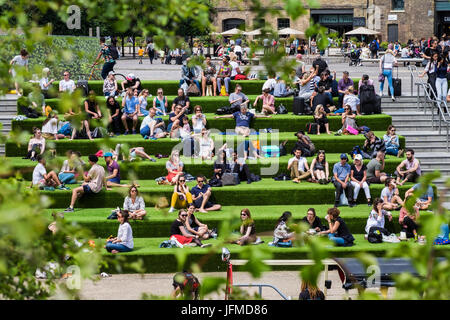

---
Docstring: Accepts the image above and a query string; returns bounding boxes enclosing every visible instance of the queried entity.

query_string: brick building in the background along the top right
[213,0,450,42]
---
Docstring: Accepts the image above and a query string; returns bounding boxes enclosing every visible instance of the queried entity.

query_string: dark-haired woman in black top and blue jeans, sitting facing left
[320,207,355,247]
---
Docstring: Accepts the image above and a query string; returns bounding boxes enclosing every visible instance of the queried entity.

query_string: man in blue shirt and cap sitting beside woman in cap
[333,153,356,207]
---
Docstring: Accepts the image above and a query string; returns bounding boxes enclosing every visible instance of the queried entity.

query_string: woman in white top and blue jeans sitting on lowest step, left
[105,210,134,254]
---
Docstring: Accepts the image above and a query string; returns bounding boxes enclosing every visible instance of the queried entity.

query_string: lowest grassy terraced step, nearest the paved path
[97,234,450,273]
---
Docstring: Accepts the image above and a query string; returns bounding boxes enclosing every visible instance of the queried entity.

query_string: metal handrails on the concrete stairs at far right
[408,66,450,152]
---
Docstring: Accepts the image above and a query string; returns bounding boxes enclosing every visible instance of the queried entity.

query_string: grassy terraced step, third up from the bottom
[28,178,422,208]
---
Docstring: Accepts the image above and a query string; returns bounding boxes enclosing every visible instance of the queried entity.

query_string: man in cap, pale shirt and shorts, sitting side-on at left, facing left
[64,154,111,212]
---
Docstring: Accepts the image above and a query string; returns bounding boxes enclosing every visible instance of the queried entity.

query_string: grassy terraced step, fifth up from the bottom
[5,128,405,157]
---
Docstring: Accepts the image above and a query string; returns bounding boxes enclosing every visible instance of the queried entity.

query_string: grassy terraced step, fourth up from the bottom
[6,153,404,180]
